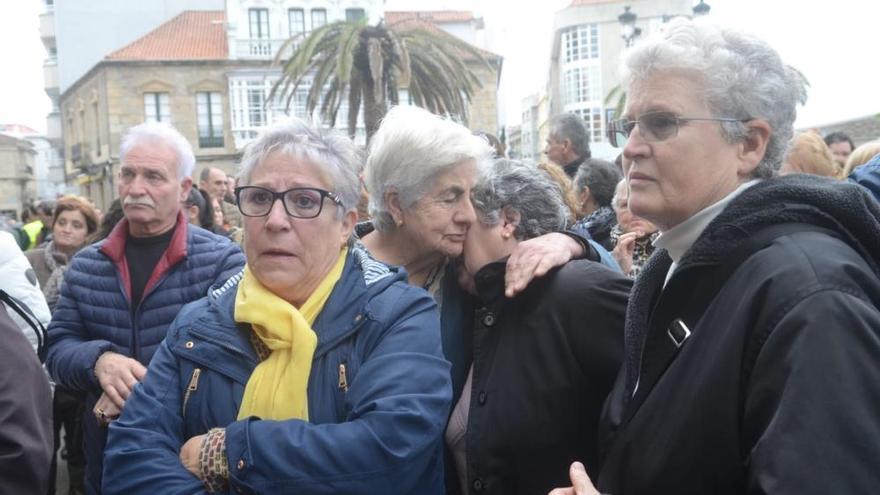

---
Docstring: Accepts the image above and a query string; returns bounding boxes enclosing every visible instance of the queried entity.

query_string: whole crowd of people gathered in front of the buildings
[0,19,880,495]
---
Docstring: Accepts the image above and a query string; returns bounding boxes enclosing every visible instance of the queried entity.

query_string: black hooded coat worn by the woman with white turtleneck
[598,176,880,495]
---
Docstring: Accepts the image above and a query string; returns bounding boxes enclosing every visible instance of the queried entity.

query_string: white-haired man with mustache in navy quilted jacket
[46,123,244,493]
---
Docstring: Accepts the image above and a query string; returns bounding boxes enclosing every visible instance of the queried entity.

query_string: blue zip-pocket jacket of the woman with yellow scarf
[104,247,452,495]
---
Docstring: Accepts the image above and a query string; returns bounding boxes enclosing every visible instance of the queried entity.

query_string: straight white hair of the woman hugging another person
[364,106,494,232]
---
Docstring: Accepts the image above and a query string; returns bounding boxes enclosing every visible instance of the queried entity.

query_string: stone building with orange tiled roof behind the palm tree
[59,0,501,209]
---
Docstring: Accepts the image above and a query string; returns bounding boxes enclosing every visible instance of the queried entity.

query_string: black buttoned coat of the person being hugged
[447,260,631,494]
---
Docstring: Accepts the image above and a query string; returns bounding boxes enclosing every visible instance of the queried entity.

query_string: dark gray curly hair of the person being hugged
[474,159,569,241]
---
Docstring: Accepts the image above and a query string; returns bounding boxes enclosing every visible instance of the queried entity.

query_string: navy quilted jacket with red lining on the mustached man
[46,215,244,493]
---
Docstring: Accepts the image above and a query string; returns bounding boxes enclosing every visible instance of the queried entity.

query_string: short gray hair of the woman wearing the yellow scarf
[239,118,362,218]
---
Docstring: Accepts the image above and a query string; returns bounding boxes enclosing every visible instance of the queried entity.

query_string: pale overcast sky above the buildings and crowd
[0,0,880,131]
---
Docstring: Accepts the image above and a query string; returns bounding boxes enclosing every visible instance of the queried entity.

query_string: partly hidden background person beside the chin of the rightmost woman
[611,180,660,278]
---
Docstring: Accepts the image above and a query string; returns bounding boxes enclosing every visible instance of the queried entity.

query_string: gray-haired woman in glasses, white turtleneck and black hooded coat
[558,20,880,495]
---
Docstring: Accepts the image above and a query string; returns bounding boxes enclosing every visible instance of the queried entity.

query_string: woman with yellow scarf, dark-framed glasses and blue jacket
[104,121,451,494]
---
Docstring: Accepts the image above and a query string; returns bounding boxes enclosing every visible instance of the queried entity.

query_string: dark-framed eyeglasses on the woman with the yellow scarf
[235,186,342,218]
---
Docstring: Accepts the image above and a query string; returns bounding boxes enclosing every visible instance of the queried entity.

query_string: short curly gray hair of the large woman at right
[621,18,806,178]
